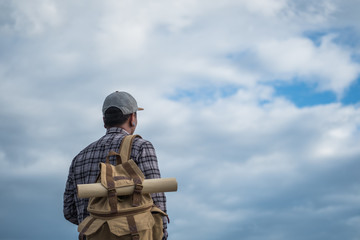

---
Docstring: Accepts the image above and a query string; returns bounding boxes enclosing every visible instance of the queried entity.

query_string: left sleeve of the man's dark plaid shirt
[63,163,79,225]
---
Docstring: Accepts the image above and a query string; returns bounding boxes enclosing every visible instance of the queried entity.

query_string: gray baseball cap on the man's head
[102,91,144,116]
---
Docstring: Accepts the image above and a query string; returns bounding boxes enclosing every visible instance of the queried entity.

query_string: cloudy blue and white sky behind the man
[0,0,360,240]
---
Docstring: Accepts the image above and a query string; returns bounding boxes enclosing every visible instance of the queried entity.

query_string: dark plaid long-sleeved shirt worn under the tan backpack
[63,127,167,236]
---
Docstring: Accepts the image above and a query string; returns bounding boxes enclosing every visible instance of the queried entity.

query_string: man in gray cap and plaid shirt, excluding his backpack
[63,91,167,239]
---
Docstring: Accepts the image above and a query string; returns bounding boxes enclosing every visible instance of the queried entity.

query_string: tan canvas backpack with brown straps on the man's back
[78,135,167,240]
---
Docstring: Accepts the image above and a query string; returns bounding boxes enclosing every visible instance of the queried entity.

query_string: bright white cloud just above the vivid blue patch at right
[258,36,360,97]
